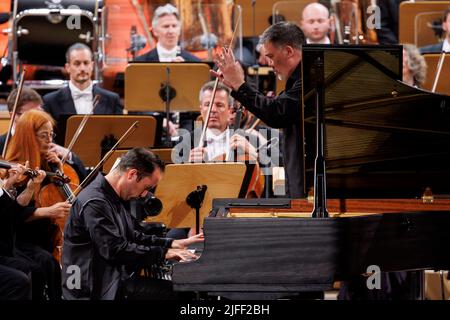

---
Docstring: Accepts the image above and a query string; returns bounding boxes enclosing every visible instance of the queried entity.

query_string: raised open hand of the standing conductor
[211,48,245,91]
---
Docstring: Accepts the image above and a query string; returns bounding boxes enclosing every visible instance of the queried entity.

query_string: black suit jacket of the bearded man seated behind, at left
[44,85,123,122]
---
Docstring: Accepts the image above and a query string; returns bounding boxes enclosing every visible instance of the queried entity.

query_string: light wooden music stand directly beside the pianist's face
[146,163,246,230]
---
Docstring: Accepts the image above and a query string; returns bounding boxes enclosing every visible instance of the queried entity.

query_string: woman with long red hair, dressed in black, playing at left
[6,110,74,299]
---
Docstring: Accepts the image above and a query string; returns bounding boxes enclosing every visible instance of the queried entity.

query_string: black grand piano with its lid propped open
[172,46,450,297]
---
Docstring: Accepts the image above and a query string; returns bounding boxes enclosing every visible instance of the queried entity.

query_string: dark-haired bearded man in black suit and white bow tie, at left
[43,43,123,122]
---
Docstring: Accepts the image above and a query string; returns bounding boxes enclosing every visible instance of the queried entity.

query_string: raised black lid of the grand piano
[302,45,450,198]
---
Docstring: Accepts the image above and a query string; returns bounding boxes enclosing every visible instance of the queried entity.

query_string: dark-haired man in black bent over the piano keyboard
[62,148,203,300]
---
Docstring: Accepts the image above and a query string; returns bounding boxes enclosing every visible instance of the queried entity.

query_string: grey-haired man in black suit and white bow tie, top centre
[134,4,200,62]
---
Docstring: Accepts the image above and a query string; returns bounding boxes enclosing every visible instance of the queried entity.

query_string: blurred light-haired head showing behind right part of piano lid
[403,43,427,88]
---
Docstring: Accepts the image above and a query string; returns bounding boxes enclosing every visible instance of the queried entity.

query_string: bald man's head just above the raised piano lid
[300,2,331,43]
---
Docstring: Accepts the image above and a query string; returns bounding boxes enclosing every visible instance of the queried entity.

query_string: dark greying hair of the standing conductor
[259,22,305,49]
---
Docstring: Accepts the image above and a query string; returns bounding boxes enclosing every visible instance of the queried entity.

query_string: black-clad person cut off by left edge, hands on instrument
[0,164,45,300]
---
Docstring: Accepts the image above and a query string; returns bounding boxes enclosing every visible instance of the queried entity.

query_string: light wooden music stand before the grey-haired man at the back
[125,63,210,146]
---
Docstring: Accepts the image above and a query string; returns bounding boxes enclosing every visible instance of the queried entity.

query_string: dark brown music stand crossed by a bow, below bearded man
[64,115,156,167]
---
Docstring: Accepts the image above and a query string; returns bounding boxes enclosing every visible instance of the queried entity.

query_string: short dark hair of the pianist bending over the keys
[118,148,165,181]
